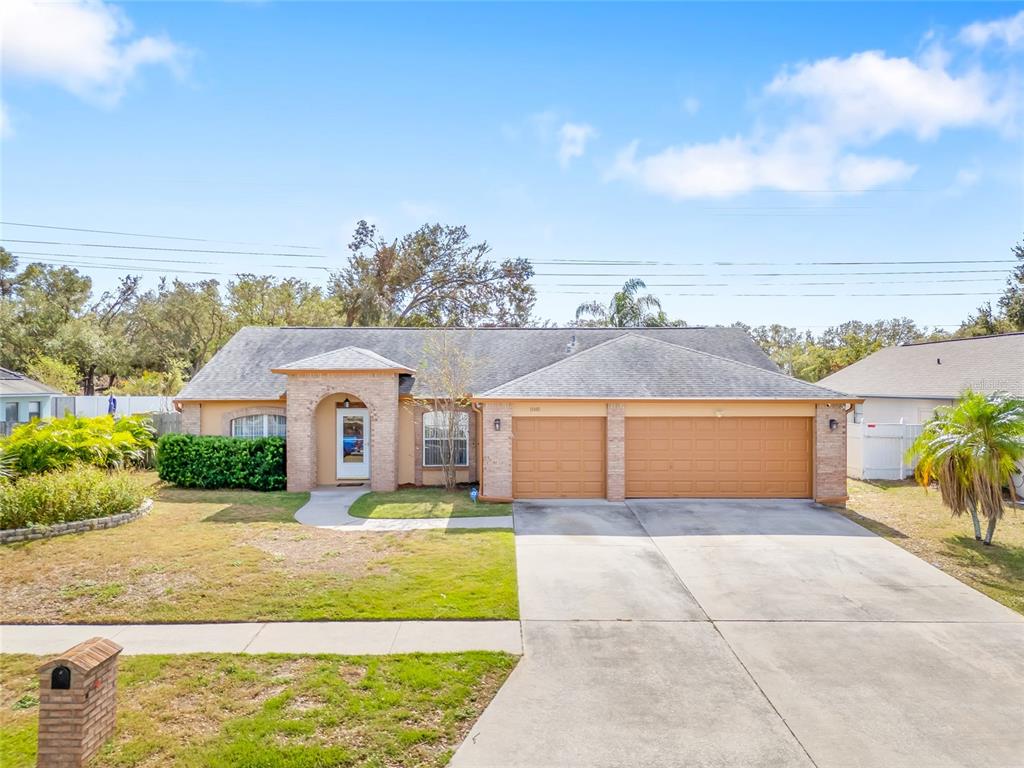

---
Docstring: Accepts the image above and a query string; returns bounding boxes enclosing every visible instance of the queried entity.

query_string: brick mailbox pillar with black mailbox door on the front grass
[36,637,121,768]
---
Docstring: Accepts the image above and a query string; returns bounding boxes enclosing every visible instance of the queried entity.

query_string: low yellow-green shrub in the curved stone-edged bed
[0,465,145,529]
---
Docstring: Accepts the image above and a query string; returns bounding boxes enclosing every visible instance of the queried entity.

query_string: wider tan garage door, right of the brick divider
[626,417,812,499]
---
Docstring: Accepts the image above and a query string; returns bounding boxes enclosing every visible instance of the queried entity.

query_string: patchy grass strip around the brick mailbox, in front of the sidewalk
[0,652,516,768]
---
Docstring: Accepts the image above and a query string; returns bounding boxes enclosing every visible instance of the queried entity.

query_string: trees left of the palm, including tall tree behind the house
[0,221,537,394]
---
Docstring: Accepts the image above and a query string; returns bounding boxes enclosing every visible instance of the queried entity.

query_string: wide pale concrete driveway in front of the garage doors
[452,501,1024,768]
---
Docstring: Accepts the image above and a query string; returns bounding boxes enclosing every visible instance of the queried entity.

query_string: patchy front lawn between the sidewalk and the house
[0,484,518,624]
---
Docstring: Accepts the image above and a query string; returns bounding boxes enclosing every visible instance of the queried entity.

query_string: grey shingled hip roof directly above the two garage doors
[479,333,846,400]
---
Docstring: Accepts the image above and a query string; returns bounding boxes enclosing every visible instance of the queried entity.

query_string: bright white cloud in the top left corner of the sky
[0,0,185,105]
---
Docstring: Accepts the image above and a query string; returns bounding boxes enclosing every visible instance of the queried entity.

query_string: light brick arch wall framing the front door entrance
[287,373,398,490]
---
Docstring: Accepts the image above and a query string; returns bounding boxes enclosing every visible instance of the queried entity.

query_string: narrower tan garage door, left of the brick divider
[512,417,605,499]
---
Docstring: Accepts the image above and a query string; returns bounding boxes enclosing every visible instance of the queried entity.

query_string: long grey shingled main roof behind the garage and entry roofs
[178,327,778,400]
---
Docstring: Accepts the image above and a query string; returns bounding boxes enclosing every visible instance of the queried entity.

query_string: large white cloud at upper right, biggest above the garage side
[606,46,1016,199]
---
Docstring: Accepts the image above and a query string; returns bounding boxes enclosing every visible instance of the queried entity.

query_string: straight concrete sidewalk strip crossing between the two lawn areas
[0,622,522,655]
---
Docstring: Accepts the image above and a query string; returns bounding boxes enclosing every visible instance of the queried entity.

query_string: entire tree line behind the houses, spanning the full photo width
[0,221,1024,394]
